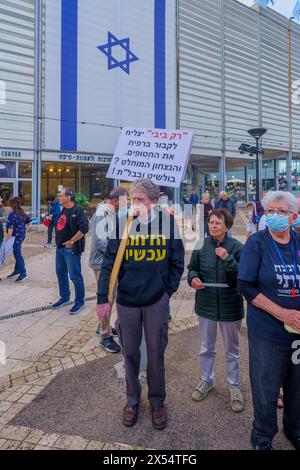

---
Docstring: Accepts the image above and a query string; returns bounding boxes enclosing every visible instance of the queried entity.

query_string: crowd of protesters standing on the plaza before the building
[0,180,300,450]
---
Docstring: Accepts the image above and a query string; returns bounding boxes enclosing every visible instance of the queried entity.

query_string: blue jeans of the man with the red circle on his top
[56,248,85,305]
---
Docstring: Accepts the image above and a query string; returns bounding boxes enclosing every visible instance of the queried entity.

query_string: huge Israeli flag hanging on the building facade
[44,0,176,153]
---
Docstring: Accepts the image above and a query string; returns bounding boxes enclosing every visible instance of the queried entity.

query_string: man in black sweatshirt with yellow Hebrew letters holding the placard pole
[97,179,184,429]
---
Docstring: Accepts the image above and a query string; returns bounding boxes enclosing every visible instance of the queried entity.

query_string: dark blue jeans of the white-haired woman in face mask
[249,332,300,442]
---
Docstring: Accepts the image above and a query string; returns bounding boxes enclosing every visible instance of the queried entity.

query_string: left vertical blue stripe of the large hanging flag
[60,0,78,151]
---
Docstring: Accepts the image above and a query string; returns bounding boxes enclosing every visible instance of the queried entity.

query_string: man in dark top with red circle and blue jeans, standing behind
[52,188,89,315]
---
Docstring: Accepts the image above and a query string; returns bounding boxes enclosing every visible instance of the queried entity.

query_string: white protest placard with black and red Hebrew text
[106,128,194,188]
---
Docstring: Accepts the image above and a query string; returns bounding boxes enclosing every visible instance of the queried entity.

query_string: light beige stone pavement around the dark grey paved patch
[0,211,278,449]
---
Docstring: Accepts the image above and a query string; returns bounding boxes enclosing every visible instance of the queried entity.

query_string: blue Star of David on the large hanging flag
[97,31,139,75]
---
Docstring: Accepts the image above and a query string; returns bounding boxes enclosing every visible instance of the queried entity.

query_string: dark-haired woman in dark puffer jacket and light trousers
[188,209,245,413]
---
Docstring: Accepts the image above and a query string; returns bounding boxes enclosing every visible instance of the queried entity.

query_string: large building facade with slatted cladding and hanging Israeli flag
[0,0,300,210]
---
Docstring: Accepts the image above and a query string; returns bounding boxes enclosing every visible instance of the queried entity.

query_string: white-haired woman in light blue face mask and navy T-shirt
[238,191,300,450]
